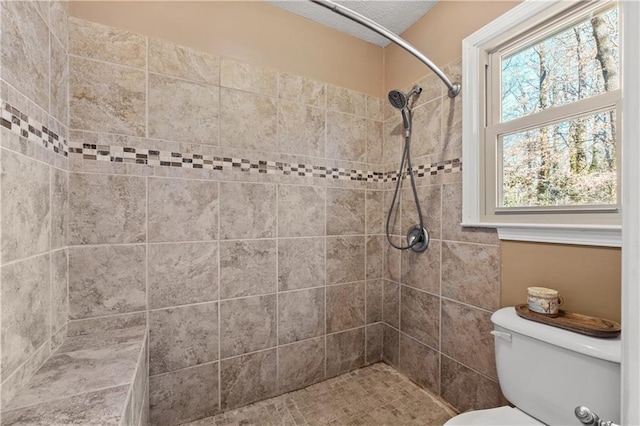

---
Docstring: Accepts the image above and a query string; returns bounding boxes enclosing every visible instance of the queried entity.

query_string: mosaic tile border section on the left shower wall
[0,101,69,157]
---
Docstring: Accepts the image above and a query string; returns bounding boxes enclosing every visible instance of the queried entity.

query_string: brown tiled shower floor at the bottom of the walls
[188,363,455,426]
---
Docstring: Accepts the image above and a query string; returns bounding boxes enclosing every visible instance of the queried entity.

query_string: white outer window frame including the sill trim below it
[461,0,624,247]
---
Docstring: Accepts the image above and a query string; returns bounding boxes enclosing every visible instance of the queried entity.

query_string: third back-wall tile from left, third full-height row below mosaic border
[220,294,277,358]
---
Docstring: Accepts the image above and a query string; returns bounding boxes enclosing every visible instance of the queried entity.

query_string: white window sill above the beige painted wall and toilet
[462,223,622,247]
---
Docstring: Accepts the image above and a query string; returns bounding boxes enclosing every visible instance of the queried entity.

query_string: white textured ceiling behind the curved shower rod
[267,0,438,47]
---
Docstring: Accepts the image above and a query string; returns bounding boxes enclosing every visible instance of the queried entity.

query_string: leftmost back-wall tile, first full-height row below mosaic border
[69,173,147,244]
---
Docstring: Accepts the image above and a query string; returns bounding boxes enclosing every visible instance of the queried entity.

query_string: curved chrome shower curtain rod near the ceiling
[309,0,460,98]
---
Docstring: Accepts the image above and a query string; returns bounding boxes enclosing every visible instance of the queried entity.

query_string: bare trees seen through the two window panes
[497,8,620,207]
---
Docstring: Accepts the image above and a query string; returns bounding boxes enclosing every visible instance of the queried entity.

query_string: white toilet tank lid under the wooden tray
[491,307,622,363]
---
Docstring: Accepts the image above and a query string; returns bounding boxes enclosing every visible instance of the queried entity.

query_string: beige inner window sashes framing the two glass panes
[480,1,622,218]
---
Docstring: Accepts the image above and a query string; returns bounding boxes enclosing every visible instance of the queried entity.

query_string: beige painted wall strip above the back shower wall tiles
[70,1,383,96]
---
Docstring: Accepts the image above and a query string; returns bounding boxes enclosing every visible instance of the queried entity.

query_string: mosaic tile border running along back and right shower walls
[70,142,462,182]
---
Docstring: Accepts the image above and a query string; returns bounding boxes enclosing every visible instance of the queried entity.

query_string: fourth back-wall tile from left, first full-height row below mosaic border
[278,185,326,237]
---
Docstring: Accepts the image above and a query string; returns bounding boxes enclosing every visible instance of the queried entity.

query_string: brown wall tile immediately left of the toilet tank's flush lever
[442,300,498,380]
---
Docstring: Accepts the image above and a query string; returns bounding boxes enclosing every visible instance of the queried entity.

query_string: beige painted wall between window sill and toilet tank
[501,241,621,321]
